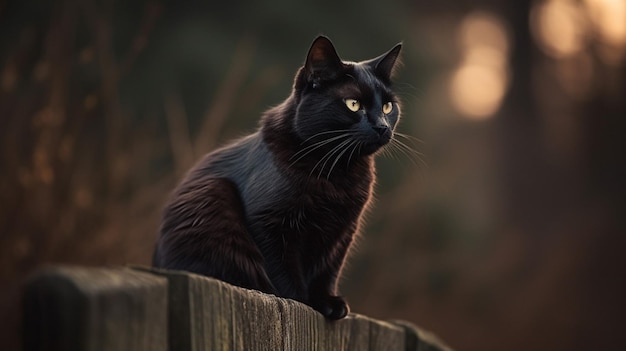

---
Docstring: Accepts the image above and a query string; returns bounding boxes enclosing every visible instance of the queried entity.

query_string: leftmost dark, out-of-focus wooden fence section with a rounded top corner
[23,267,167,351]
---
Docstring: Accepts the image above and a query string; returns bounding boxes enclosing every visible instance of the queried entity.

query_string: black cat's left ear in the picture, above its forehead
[304,35,344,88]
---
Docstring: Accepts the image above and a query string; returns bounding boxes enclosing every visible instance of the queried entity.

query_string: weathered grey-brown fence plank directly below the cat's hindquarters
[137,267,283,351]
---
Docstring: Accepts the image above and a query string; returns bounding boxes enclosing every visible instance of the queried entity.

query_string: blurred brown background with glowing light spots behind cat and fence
[0,0,626,350]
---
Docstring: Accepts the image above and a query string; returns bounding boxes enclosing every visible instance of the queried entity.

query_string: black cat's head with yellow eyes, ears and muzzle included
[294,36,401,155]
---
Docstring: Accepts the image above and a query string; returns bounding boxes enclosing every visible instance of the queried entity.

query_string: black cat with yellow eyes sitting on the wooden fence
[153,36,401,319]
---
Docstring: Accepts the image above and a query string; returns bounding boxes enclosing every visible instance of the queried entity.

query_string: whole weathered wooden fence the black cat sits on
[23,266,449,351]
